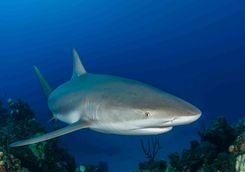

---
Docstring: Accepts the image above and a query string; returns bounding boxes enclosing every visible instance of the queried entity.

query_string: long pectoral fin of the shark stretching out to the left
[9,121,89,147]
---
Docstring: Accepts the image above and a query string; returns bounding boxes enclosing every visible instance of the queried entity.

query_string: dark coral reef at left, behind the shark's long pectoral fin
[0,99,76,172]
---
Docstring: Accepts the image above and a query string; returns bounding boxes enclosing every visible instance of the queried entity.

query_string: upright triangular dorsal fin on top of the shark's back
[72,48,86,79]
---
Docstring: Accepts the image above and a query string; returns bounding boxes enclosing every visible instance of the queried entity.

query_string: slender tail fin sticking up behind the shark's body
[33,65,52,100]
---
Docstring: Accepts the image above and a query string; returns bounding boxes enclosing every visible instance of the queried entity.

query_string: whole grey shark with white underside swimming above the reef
[10,49,201,147]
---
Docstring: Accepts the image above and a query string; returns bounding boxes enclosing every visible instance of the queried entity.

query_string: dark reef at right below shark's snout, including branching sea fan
[135,117,245,172]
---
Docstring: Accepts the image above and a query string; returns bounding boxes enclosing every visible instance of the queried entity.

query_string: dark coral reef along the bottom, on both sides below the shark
[0,99,245,172]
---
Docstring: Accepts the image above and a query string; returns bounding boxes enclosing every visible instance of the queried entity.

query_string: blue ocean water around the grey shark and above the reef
[0,0,245,172]
